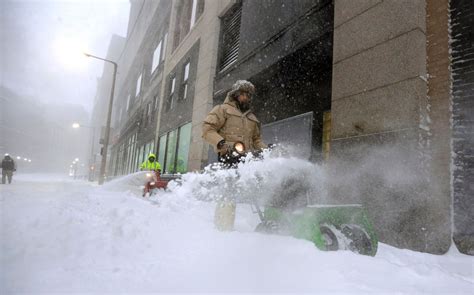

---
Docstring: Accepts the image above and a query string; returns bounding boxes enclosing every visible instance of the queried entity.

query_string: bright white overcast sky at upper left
[0,0,130,111]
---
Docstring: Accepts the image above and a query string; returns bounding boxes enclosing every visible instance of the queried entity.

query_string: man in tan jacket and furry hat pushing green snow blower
[202,80,267,230]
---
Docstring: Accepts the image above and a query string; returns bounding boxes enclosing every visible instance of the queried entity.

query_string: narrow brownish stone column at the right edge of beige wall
[426,0,452,254]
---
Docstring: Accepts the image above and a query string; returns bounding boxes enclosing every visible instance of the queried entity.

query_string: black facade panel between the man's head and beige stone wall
[250,35,332,160]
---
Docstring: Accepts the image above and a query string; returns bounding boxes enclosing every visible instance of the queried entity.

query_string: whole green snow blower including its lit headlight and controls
[221,142,378,256]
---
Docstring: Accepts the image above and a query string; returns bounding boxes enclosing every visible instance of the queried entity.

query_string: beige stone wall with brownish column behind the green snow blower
[331,0,450,253]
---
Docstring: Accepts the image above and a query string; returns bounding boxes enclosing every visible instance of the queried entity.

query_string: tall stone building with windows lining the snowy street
[90,0,474,254]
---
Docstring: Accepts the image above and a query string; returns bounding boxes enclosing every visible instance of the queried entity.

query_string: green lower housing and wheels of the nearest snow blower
[253,201,378,256]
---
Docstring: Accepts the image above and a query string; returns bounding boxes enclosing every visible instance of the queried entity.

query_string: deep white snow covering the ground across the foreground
[0,166,474,294]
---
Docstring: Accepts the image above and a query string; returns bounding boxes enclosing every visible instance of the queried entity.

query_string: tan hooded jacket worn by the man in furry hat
[202,95,267,152]
